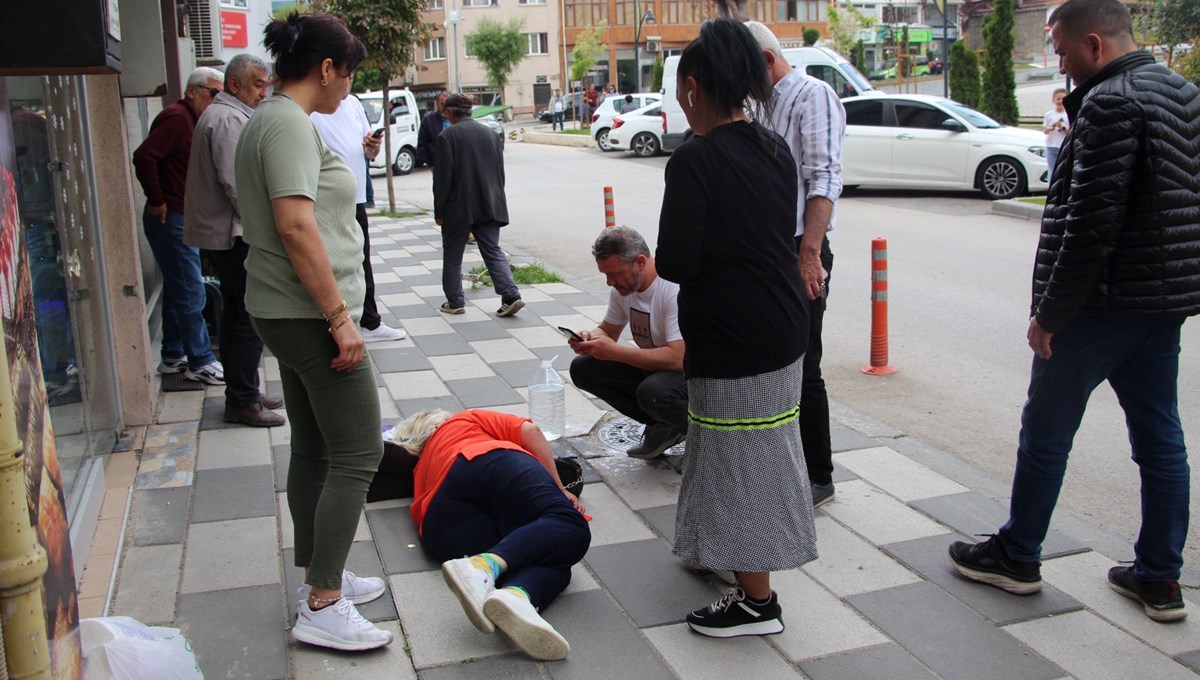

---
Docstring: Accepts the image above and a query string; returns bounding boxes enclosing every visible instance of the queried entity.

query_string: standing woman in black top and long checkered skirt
[655,18,817,638]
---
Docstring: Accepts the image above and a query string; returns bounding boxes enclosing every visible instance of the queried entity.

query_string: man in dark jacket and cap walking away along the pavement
[433,92,524,317]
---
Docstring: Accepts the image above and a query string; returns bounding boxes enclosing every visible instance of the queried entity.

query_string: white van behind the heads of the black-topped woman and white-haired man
[662,47,875,151]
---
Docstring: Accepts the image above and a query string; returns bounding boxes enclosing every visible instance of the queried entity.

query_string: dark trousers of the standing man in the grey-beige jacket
[204,237,263,408]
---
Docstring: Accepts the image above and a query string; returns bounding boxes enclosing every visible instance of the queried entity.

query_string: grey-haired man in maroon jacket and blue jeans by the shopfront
[133,66,224,385]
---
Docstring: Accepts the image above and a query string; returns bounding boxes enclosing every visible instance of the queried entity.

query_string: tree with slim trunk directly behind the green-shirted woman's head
[317,0,433,212]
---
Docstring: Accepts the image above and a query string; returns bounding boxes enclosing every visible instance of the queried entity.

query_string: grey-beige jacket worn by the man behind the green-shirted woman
[184,92,254,251]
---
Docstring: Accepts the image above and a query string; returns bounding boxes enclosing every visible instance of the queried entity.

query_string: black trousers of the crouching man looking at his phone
[571,356,688,432]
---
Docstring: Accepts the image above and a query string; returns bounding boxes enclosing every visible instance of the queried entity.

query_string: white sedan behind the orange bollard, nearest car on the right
[841,94,1048,200]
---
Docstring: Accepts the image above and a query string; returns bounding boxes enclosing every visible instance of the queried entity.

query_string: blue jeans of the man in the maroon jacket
[142,210,217,368]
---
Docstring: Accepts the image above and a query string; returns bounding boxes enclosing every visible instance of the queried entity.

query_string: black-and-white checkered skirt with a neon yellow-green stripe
[674,357,817,572]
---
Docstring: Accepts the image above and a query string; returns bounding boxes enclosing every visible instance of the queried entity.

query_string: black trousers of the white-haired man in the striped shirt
[800,239,833,485]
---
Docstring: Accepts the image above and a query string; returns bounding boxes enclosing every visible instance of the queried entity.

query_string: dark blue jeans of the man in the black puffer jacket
[1000,315,1189,580]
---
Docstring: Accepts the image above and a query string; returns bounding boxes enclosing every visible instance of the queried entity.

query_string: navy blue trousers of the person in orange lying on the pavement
[421,449,592,609]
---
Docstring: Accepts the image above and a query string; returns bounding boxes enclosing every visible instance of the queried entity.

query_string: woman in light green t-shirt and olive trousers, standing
[235,12,392,651]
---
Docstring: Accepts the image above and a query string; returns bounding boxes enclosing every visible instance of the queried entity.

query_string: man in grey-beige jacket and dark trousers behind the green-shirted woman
[184,54,287,427]
